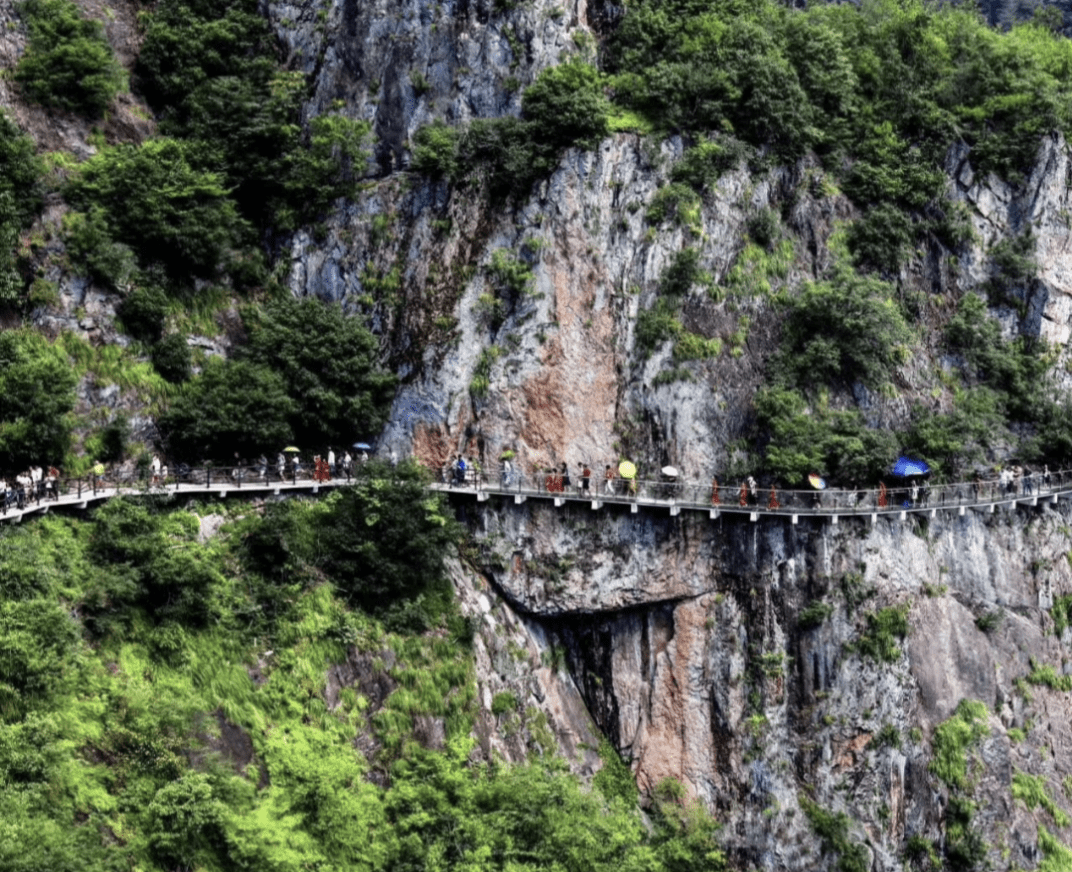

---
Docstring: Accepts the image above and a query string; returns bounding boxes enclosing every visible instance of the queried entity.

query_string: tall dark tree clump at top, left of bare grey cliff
[135,0,370,230]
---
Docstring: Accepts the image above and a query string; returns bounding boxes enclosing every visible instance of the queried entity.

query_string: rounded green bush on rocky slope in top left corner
[15,0,126,118]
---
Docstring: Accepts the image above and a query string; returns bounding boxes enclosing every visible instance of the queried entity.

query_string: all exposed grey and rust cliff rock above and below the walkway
[271,0,1072,870]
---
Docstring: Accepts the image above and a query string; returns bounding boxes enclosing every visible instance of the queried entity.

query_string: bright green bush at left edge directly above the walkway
[0,330,77,470]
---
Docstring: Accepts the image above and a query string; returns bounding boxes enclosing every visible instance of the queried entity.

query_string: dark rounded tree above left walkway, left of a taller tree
[157,360,299,463]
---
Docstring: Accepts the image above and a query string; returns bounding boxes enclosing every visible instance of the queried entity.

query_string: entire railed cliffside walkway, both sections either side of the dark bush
[0,468,1072,524]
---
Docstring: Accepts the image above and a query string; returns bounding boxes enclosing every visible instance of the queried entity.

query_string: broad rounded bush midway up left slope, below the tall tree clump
[68,138,240,278]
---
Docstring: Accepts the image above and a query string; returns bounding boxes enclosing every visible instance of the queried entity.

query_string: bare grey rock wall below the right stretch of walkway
[459,498,1072,870]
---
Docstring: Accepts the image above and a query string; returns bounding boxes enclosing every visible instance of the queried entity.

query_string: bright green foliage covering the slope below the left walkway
[0,486,725,872]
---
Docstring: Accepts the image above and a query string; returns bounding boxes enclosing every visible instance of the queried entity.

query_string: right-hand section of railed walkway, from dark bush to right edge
[431,471,1072,524]
